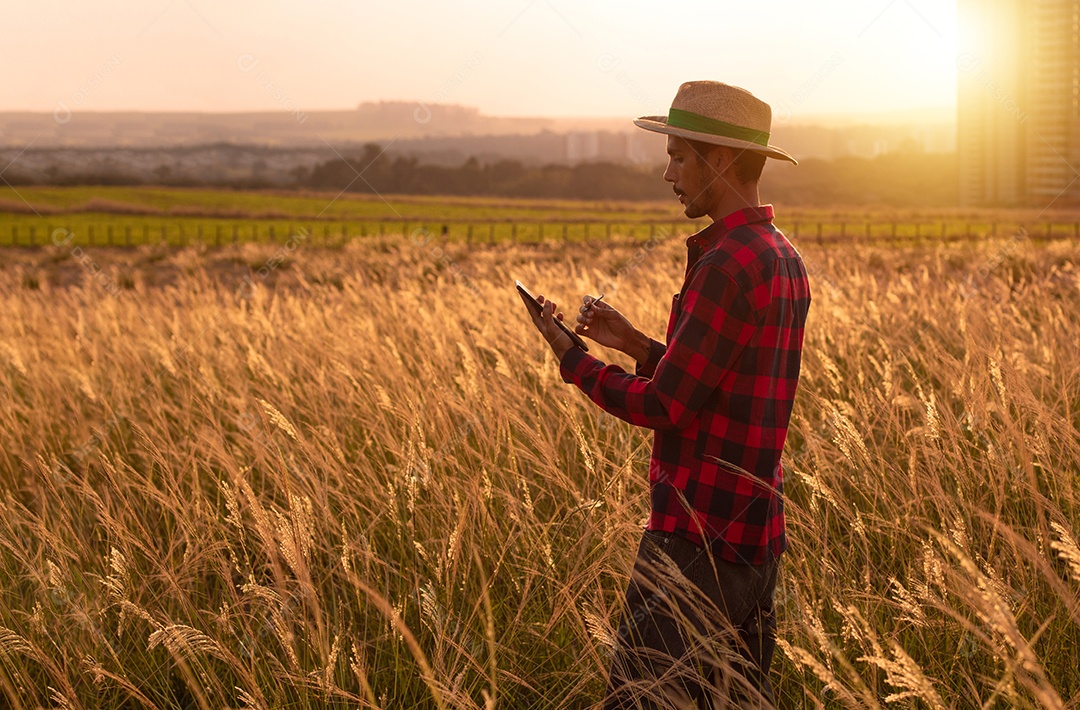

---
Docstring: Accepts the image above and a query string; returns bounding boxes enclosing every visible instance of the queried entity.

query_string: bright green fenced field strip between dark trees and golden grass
[0,187,1080,246]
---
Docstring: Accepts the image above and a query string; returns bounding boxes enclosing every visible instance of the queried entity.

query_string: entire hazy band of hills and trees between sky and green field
[0,102,956,206]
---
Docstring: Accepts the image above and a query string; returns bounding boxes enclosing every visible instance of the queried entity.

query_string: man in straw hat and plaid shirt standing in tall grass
[522,81,810,708]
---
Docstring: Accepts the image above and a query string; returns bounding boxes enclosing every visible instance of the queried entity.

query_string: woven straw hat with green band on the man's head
[634,81,798,165]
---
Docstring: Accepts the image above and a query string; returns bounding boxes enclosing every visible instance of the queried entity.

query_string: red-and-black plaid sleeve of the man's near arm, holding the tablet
[559,264,757,429]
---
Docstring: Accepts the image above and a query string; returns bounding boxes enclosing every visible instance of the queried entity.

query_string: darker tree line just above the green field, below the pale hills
[5,144,958,207]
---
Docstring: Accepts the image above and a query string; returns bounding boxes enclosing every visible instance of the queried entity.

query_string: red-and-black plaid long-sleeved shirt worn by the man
[559,205,810,564]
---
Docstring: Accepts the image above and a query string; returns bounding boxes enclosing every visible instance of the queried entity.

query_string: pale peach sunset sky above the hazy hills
[0,0,961,119]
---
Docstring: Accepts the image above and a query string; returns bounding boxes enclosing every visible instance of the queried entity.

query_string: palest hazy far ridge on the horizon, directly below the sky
[0,102,956,163]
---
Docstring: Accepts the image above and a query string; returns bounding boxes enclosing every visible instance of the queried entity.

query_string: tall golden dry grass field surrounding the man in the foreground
[0,230,1080,710]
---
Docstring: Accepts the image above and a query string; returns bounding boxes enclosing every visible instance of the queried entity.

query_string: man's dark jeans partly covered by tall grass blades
[604,531,778,710]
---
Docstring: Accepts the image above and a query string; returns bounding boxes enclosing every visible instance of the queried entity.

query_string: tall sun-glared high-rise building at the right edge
[957,0,1080,207]
